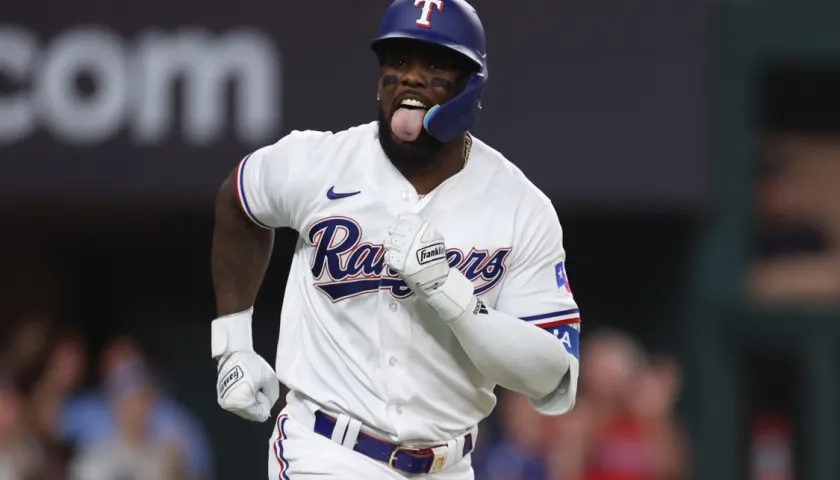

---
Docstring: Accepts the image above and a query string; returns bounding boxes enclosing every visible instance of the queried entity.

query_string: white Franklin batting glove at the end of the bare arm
[211,308,280,422]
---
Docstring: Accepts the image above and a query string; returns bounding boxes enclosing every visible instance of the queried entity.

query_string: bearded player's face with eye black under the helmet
[378,40,471,173]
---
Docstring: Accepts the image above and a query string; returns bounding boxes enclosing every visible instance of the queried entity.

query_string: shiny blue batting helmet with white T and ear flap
[371,0,487,142]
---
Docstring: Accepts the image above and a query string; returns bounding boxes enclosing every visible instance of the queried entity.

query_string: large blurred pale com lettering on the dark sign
[0,25,280,147]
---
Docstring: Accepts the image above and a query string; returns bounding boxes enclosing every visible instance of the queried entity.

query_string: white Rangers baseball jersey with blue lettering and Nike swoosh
[237,122,579,442]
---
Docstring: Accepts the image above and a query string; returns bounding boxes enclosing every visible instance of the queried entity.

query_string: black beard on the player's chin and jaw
[379,105,444,178]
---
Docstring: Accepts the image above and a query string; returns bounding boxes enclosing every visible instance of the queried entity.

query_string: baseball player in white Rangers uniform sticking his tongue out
[212,0,580,480]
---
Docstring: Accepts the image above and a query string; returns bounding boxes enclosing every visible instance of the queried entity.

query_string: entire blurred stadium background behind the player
[0,0,840,480]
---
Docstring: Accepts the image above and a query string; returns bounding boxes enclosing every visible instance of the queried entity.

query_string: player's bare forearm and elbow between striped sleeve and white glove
[211,170,274,316]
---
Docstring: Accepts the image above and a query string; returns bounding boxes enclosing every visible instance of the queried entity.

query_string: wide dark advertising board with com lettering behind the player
[0,0,706,208]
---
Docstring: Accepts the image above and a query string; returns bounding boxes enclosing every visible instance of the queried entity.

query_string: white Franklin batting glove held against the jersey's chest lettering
[385,213,476,322]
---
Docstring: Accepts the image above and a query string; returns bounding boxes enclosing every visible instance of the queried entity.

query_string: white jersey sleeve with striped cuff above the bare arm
[236,132,308,229]
